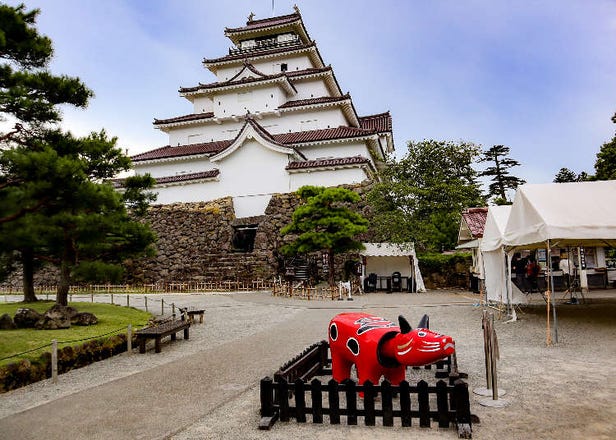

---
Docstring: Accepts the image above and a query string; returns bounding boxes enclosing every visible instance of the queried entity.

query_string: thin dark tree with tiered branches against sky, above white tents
[479,145,526,205]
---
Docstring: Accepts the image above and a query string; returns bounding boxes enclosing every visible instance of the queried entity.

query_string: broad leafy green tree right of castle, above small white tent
[367,140,485,251]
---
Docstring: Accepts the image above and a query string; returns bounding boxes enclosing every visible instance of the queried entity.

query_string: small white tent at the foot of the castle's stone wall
[360,243,426,292]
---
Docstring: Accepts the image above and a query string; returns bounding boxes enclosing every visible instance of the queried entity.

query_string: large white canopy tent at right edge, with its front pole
[503,180,616,344]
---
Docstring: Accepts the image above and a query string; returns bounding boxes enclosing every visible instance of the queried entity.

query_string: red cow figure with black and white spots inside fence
[329,313,455,385]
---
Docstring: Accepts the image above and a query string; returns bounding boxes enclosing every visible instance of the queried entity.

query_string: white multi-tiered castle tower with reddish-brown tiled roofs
[132,8,394,218]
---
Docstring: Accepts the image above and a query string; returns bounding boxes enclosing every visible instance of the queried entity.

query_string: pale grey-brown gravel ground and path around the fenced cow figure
[0,291,616,440]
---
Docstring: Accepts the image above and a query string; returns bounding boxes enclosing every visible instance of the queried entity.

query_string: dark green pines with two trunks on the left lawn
[0,4,154,304]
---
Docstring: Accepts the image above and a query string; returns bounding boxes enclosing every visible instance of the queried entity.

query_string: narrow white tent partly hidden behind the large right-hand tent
[479,206,527,305]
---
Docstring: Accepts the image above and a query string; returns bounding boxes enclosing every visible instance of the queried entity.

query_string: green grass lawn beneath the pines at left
[0,301,152,365]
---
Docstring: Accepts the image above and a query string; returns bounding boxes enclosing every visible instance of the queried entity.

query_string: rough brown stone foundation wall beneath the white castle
[3,185,378,288]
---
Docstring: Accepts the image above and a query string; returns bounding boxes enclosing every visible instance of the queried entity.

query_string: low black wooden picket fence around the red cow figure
[259,341,471,438]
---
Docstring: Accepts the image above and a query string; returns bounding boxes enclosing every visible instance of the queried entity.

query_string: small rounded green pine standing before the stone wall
[280,186,368,286]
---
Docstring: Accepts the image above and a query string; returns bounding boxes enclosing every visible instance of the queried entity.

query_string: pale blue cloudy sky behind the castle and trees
[9,0,616,183]
